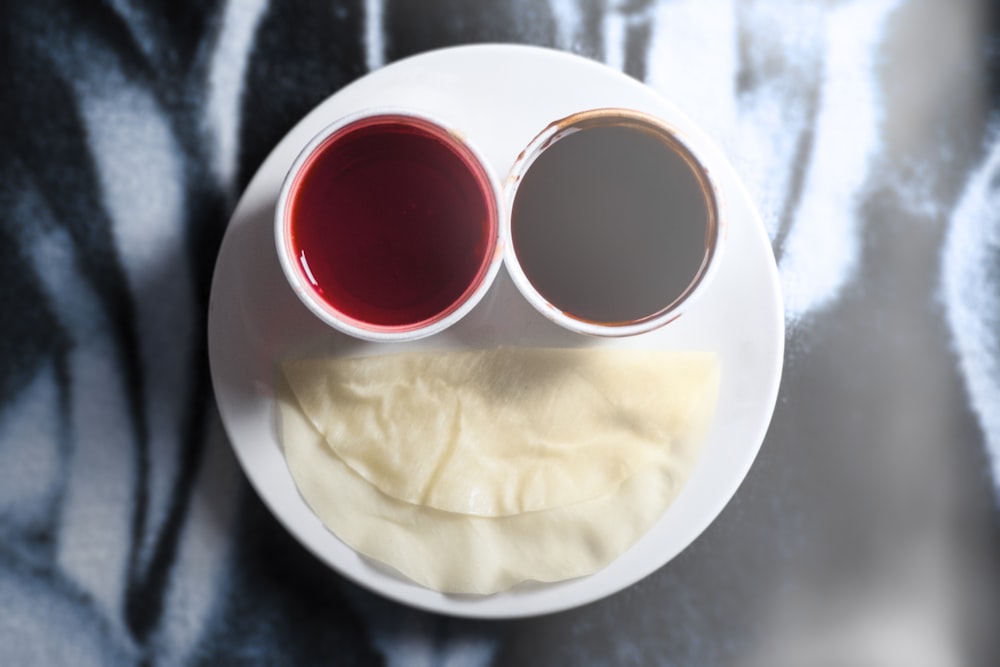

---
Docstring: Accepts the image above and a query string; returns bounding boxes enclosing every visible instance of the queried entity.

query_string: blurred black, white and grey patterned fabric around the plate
[0,0,1000,667]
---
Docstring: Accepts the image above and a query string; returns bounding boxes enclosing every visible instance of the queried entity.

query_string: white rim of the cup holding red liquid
[274,107,510,342]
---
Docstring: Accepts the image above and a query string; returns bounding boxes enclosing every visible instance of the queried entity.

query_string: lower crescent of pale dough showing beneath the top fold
[278,394,689,594]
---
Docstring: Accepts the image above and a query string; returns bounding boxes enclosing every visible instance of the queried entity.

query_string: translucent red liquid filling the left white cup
[289,117,498,330]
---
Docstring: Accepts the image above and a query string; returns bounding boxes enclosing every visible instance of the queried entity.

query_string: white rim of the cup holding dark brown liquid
[504,107,727,338]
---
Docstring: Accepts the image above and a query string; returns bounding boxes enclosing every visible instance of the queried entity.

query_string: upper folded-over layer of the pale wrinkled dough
[284,347,719,520]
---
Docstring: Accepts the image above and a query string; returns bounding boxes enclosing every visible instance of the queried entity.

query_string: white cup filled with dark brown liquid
[505,109,725,336]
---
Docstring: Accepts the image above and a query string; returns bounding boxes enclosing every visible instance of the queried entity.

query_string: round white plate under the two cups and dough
[208,45,784,618]
